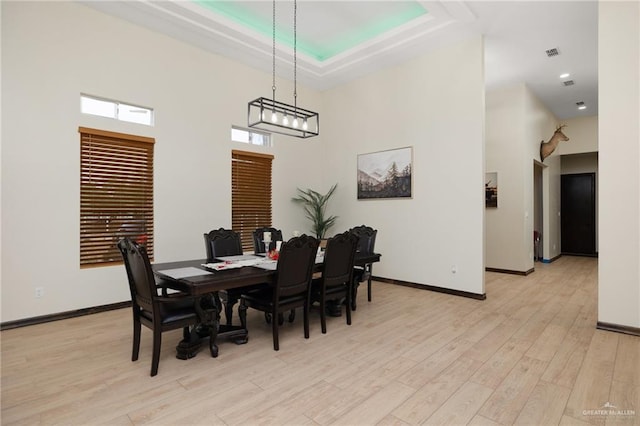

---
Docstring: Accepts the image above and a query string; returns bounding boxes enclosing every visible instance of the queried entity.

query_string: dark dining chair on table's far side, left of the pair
[204,228,267,325]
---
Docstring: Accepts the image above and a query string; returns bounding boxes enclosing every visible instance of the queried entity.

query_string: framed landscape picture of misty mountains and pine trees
[358,147,413,200]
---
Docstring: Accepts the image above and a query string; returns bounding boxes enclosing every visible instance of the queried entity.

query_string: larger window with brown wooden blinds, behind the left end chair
[78,127,155,267]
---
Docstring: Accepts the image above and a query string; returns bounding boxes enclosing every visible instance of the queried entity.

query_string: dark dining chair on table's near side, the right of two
[311,231,359,334]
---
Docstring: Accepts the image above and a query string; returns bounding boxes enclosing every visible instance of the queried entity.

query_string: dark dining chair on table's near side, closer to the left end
[238,234,318,351]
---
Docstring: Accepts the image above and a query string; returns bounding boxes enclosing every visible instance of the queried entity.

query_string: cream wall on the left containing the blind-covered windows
[1,2,325,322]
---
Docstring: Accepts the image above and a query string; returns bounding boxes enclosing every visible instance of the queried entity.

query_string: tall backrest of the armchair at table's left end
[118,238,158,312]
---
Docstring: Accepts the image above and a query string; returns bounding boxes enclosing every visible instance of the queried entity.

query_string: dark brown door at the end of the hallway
[560,173,596,256]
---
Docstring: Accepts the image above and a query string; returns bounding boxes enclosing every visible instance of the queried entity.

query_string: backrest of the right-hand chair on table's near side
[322,231,359,287]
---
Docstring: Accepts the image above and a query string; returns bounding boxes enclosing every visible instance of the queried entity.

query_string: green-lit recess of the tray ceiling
[193,0,427,62]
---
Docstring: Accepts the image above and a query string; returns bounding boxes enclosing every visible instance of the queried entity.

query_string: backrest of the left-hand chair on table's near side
[273,234,318,303]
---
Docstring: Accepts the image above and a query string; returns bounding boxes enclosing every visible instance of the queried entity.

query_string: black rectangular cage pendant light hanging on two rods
[247,0,320,138]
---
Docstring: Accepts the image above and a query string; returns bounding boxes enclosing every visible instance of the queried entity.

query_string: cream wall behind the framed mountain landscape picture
[323,38,484,297]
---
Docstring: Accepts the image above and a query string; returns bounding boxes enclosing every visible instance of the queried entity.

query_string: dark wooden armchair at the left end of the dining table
[118,238,200,376]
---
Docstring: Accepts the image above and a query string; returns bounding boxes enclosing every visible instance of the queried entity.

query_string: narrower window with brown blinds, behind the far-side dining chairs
[231,150,273,251]
